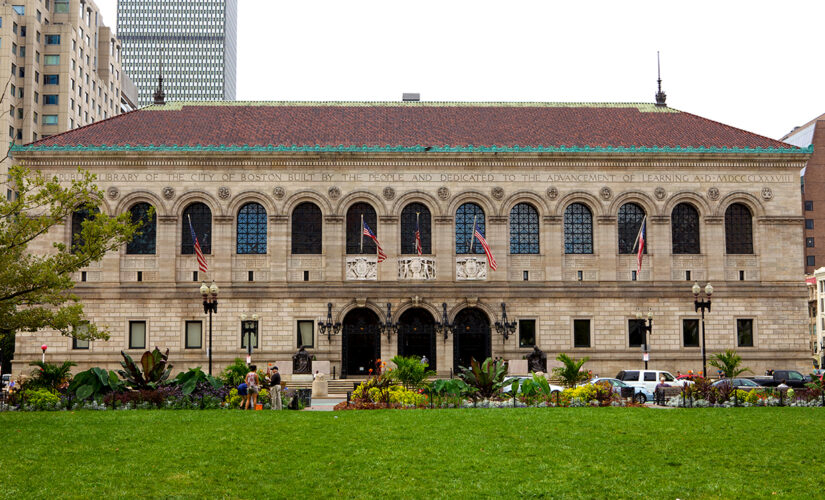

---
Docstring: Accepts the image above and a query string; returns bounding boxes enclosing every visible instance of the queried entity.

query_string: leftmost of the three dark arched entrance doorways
[341,308,381,378]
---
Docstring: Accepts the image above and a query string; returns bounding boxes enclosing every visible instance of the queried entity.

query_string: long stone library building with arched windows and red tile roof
[8,101,810,378]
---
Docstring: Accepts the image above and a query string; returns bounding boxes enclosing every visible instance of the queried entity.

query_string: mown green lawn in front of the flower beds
[0,408,825,498]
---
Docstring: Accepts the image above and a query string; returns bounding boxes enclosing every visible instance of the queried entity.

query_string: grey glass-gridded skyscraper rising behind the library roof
[117,0,238,106]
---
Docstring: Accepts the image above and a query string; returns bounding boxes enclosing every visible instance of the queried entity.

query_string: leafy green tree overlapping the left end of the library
[0,166,140,339]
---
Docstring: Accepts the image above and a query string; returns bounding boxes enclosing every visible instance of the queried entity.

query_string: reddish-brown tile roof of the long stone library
[20,102,799,151]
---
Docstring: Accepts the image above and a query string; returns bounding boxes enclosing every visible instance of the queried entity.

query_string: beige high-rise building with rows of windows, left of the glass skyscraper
[0,0,136,180]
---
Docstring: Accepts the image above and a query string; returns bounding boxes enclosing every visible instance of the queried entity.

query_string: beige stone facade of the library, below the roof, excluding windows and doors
[14,151,811,376]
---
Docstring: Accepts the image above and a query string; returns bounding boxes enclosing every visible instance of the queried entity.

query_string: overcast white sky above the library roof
[96,0,825,138]
